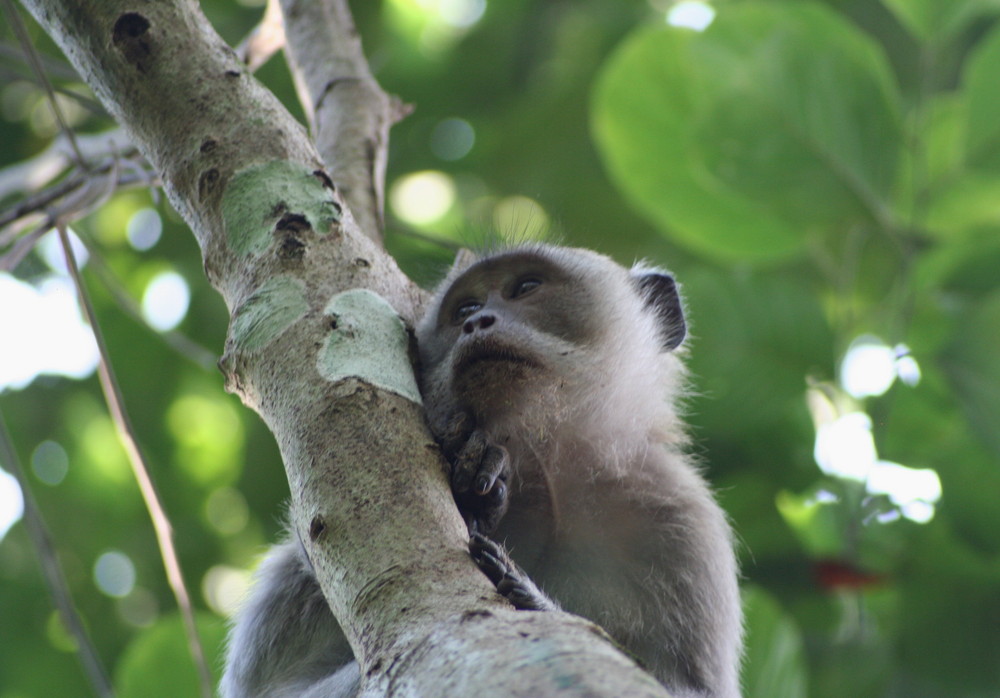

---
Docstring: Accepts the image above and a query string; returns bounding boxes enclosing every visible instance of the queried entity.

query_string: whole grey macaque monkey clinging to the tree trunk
[222,245,742,698]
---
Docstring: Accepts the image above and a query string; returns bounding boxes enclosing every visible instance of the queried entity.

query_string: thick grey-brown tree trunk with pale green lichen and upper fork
[17,0,665,696]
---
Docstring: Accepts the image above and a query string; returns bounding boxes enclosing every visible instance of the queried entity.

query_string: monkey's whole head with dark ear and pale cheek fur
[417,245,686,440]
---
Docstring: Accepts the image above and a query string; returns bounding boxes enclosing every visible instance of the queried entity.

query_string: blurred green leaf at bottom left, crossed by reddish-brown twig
[115,614,226,698]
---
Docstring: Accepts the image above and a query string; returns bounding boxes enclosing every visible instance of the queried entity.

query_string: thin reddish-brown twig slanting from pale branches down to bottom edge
[56,221,212,698]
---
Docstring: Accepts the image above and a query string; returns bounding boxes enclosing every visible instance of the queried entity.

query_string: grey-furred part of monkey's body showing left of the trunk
[219,540,358,698]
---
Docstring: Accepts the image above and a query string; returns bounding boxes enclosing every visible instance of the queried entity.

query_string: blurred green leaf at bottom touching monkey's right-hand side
[743,586,808,698]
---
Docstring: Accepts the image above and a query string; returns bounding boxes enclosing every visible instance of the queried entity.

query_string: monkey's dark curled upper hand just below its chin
[451,430,510,533]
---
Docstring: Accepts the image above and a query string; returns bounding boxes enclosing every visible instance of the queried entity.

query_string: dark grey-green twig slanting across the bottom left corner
[0,413,115,698]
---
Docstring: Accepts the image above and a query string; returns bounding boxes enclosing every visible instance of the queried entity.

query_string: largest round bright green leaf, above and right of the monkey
[592,2,900,261]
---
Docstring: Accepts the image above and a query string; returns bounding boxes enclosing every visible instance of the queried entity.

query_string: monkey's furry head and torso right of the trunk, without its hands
[417,245,742,698]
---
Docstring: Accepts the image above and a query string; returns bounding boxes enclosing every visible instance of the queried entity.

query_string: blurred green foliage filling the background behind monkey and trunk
[0,0,1000,698]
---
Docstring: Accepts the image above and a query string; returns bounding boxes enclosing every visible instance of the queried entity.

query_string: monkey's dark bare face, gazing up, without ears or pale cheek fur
[420,250,598,415]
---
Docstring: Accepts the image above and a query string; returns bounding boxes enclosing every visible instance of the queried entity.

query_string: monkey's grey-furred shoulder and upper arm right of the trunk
[540,470,742,698]
